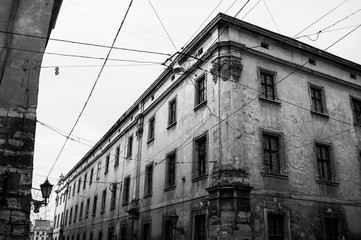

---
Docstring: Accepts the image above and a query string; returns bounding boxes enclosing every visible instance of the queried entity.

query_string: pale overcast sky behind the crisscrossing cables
[32,0,361,219]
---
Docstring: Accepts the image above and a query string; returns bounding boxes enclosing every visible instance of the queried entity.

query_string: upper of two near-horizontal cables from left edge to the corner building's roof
[0,30,171,56]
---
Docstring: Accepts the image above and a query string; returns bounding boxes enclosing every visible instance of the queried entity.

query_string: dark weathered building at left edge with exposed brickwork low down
[0,0,62,239]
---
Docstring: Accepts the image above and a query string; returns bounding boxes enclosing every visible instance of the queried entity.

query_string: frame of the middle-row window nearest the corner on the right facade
[261,129,287,177]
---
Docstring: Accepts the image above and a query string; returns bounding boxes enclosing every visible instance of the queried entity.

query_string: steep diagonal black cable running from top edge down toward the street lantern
[48,0,133,176]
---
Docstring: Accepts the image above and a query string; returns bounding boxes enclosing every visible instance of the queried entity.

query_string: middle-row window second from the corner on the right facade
[316,143,332,181]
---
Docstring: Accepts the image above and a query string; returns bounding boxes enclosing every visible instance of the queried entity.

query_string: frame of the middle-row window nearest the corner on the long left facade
[192,132,209,180]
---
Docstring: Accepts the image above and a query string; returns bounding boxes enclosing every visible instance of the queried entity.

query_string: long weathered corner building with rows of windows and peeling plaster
[54,14,361,240]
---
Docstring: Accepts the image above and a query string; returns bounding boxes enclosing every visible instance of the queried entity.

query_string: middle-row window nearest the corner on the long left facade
[193,134,207,177]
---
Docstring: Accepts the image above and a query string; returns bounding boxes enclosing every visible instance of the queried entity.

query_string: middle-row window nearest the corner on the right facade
[262,132,282,174]
